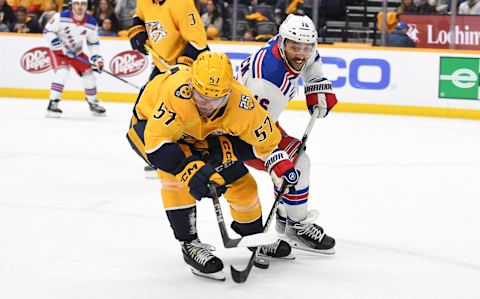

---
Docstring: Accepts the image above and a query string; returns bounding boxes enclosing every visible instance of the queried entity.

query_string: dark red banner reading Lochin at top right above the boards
[399,14,480,50]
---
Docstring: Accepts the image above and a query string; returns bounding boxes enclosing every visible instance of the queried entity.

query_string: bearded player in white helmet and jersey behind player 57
[237,15,337,254]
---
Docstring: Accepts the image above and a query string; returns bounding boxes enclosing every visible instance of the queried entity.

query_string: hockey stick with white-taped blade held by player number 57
[208,183,278,248]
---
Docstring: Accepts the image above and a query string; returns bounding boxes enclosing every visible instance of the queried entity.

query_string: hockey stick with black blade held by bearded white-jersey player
[230,107,320,283]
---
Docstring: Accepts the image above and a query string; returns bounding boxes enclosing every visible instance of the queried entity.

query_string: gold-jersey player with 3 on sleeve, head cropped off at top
[128,0,208,178]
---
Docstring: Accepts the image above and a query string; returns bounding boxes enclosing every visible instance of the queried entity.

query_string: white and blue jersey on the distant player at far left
[43,10,100,56]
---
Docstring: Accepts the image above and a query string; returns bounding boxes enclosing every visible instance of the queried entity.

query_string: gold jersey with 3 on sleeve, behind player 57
[135,0,207,70]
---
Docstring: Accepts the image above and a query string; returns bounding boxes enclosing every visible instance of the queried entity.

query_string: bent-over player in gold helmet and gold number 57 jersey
[127,51,299,279]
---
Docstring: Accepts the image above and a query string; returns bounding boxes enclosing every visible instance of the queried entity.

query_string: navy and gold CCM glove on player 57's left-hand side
[176,160,227,200]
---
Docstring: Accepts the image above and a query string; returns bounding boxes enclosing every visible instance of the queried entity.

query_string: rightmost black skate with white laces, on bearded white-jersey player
[285,210,335,254]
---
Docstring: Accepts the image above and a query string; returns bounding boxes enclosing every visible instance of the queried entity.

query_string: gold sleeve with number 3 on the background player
[172,0,207,51]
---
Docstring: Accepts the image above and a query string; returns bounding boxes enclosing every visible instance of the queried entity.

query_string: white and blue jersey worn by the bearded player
[237,35,324,121]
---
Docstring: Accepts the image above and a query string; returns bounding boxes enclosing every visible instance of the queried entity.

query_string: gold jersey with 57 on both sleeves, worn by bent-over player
[135,67,281,158]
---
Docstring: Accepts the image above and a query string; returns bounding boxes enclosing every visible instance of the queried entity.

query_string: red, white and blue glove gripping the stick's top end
[305,78,337,118]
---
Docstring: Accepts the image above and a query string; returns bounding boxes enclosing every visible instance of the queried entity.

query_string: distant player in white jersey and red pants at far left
[43,0,105,117]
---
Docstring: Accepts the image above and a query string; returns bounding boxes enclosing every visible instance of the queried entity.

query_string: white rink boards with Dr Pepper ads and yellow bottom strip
[0,33,480,119]
